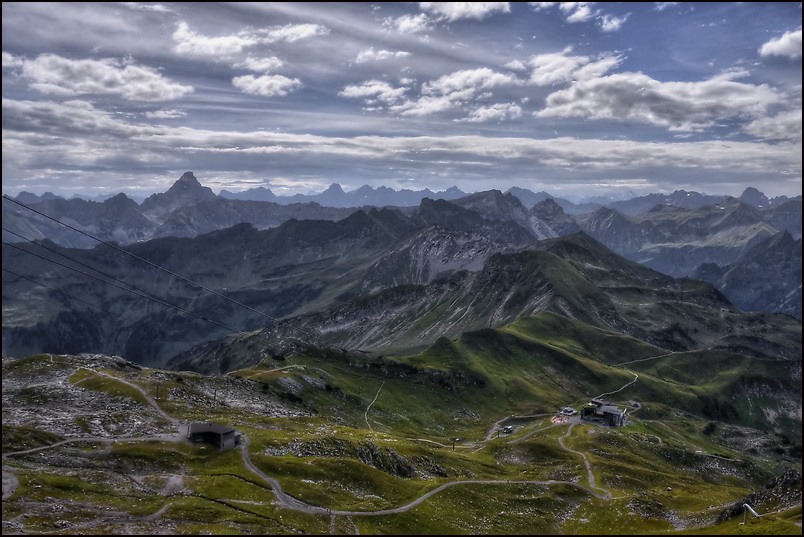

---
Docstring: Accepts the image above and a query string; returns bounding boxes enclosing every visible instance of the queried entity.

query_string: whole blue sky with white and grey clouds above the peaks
[2,2,802,198]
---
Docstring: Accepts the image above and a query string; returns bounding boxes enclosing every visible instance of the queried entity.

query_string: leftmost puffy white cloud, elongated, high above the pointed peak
[16,54,193,101]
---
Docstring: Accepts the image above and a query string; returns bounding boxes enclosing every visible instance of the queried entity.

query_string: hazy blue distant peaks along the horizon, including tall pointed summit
[3,172,802,319]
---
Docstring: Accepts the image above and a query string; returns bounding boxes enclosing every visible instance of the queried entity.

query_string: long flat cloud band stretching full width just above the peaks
[3,99,802,195]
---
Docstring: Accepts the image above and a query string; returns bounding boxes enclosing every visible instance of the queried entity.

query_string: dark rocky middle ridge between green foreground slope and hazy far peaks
[3,181,800,368]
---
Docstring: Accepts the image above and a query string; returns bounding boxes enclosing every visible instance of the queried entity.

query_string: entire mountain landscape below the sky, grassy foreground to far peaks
[2,172,802,535]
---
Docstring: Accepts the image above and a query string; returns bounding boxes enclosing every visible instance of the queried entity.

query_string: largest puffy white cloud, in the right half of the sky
[534,73,780,131]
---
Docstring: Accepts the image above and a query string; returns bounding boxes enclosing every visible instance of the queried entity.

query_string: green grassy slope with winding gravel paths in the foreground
[3,304,801,535]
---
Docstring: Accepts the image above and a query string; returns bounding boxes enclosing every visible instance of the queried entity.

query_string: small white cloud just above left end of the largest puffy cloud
[528,48,621,86]
